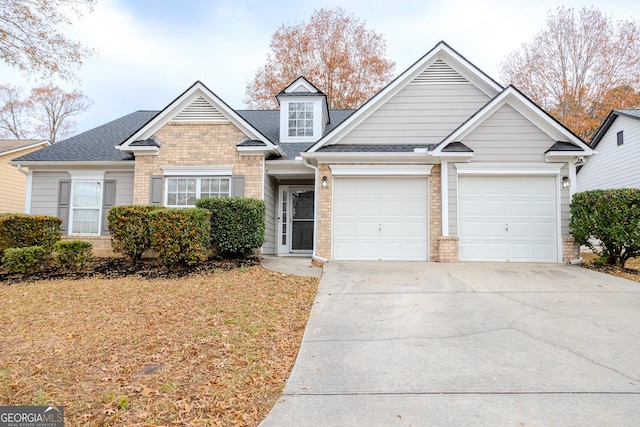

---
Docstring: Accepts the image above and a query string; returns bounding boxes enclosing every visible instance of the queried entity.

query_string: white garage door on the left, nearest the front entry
[333,177,428,261]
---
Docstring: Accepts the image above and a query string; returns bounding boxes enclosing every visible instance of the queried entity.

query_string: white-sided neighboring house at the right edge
[578,110,640,191]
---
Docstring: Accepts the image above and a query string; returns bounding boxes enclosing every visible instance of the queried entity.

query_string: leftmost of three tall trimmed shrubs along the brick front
[107,205,160,262]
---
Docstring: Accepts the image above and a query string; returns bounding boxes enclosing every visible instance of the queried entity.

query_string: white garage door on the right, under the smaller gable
[458,176,558,262]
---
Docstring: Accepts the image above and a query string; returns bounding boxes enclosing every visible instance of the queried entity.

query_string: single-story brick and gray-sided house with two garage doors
[13,42,592,262]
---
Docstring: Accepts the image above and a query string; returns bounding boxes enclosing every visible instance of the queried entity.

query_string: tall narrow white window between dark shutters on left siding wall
[71,180,102,234]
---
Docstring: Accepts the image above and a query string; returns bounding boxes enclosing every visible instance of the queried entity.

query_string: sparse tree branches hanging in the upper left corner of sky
[0,0,95,79]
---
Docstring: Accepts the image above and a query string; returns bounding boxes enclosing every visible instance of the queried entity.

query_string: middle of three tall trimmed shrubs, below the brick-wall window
[149,208,211,265]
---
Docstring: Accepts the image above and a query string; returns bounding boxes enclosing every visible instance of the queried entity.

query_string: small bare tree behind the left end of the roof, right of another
[27,84,93,144]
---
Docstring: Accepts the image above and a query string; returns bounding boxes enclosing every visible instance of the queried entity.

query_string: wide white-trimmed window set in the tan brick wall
[166,177,231,208]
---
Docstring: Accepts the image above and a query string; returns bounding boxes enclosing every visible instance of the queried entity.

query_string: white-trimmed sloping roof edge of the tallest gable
[307,41,503,153]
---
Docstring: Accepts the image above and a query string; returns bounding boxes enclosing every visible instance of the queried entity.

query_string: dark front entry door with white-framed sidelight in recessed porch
[279,186,315,254]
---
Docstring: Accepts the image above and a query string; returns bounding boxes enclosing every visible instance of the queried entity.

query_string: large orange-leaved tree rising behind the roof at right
[501,6,640,140]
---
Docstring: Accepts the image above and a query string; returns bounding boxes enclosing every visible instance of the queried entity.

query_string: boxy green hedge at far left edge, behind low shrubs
[0,214,62,255]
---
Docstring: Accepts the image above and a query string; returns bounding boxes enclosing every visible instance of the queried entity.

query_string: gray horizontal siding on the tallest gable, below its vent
[340,82,489,144]
